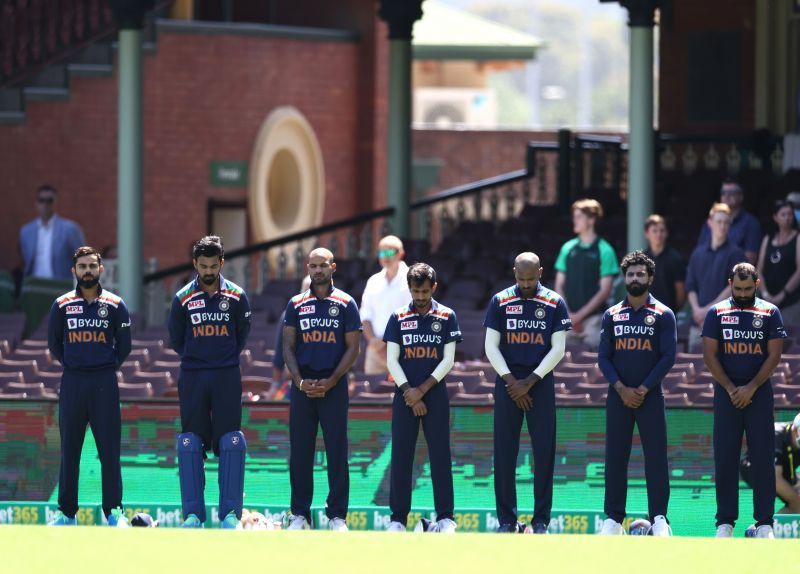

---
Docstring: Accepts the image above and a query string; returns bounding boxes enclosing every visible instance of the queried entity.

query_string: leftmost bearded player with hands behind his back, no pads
[47,246,131,527]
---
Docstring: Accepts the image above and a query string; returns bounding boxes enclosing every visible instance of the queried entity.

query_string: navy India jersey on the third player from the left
[283,287,361,378]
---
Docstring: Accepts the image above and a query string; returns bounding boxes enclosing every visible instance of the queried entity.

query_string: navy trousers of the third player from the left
[289,376,350,522]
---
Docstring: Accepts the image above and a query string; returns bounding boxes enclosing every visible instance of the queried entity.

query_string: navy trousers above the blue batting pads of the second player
[178,367,242,456]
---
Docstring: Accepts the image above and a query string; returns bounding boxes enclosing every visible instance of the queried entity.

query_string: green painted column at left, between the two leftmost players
[117,29,144,312]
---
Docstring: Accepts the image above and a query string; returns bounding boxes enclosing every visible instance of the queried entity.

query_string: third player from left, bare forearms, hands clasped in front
[283,247,361,531]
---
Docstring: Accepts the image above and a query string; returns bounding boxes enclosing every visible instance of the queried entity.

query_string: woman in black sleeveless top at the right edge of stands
[758,201,800,325]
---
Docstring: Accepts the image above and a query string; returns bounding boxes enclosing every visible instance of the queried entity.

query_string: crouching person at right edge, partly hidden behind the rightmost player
[739,413,800,514]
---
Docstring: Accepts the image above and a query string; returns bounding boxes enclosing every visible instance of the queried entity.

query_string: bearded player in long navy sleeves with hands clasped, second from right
[597,251,678,536]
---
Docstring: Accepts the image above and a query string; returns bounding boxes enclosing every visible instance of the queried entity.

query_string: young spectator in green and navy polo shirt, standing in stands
[555,199,619,348]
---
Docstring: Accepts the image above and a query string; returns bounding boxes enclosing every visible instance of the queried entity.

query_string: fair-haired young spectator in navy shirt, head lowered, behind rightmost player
[686,203,745,353]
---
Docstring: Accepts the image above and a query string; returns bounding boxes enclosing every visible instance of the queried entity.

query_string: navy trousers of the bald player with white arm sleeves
[494,375,556,524]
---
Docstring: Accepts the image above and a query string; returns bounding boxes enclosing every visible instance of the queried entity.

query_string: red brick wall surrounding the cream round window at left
[0,28,368,276]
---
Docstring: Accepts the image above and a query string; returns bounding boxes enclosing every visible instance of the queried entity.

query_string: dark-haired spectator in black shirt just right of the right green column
[644,214,686,313]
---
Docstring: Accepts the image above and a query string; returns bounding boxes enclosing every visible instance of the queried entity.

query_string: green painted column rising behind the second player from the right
[628,23,655,251]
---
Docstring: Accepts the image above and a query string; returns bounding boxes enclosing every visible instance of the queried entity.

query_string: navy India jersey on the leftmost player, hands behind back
[47,287,131,371]
